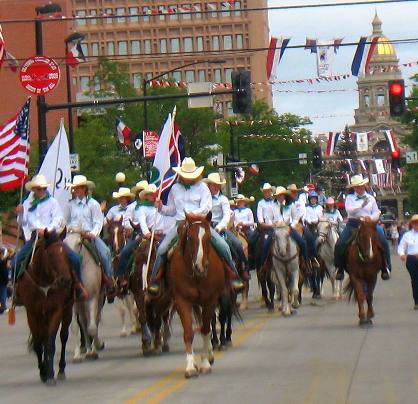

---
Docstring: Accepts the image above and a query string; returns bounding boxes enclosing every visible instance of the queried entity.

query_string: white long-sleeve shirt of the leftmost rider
[18,196,65,238]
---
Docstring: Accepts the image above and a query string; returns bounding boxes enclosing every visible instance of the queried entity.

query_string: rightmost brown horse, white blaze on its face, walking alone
[345,220,383,327]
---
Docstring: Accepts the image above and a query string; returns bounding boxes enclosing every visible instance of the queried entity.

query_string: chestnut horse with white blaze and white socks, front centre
[168,213,226,378]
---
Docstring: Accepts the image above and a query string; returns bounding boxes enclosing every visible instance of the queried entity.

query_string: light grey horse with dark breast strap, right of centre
[271,223,299,316]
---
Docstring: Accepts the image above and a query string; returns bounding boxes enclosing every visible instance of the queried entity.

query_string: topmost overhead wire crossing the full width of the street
[0,0,418,24]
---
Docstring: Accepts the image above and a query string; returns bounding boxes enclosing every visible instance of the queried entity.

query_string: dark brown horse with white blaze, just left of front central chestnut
[129,239,172,356]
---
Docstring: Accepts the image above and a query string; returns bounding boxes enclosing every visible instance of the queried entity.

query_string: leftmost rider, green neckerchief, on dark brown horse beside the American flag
[12,174,88,299]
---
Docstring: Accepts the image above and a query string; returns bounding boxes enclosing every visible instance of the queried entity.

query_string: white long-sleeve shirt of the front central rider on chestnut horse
[161,181,212,221]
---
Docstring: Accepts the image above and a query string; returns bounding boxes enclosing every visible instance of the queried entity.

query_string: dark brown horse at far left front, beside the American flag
[16,230,73,386]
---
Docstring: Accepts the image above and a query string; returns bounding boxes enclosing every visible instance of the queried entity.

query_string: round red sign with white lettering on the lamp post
[20,56,60,95]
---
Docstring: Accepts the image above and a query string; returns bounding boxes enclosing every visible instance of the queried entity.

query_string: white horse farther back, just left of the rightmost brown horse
[317,216,343,299]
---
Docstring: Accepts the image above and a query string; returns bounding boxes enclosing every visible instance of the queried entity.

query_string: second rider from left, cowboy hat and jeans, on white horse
[66,175,114,296]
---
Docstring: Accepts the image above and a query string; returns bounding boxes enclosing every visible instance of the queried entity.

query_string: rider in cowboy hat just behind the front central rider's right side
[203,173,248,280]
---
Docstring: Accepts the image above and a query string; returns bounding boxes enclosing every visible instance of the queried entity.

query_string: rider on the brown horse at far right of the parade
[334,175,392,280]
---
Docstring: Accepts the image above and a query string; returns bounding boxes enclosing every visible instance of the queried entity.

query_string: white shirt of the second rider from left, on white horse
[65,197,104,237]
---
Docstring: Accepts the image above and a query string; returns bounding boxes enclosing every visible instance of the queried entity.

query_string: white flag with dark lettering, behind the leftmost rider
[39,120,71,207]
